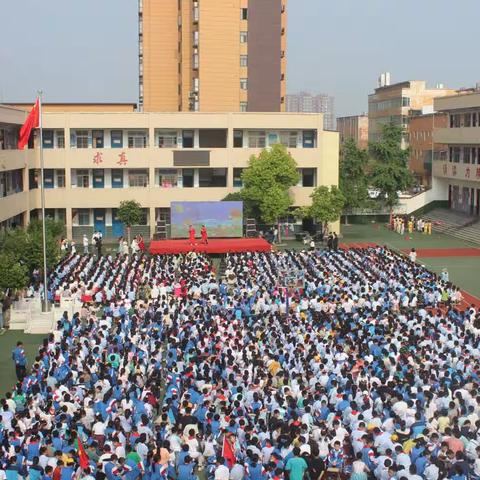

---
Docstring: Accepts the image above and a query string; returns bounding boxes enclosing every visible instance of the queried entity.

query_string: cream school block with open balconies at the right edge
[433,91,480,215]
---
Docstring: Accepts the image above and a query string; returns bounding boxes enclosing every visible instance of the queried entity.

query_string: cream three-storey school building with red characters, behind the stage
[0,105,338,239]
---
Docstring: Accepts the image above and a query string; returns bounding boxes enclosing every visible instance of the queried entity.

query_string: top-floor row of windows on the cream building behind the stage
[43,129,316,149]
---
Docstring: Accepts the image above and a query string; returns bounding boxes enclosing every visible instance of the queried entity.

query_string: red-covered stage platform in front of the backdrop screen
[150,238,272,254]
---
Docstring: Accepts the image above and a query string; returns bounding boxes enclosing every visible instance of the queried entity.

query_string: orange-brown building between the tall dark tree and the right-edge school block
[408,113,448,187]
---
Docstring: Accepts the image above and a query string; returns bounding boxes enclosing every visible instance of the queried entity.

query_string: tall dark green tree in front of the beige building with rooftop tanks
[370,123,413,211]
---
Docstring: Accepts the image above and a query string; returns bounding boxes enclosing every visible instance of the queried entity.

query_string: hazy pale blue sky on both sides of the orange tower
[0,0,480,116]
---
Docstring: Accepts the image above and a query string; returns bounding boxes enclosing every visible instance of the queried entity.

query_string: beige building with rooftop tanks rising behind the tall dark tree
[368,80,455,148]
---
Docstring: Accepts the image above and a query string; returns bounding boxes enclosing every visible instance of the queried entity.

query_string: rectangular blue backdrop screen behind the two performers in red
[171,202,243,238]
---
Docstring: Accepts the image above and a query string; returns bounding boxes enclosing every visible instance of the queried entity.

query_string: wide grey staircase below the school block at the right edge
[424,209,480,245]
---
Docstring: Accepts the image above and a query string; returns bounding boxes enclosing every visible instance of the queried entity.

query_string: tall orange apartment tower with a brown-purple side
[138,0,287,112]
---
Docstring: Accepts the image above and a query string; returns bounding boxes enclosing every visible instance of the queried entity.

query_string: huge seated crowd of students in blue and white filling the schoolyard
[0,247,480,480]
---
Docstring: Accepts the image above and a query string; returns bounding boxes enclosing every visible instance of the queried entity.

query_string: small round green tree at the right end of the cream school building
[304,185,345,232]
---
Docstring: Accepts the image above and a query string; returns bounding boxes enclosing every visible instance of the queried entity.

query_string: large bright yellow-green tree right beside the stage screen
[241,144,300,240]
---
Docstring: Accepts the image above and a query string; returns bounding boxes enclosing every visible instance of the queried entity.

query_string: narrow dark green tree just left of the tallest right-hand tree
[339,139,369,223]
